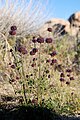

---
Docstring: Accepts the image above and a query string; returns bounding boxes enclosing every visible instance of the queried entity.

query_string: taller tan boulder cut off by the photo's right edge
[68,11,80,36]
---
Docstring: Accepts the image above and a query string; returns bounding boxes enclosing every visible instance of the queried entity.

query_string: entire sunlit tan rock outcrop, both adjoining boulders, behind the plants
[40,12,80,37]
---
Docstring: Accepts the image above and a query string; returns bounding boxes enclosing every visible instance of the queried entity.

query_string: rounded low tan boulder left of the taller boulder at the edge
[40,18,70,37]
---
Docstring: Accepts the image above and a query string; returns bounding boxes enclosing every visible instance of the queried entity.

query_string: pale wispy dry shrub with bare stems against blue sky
[0,0,50,36]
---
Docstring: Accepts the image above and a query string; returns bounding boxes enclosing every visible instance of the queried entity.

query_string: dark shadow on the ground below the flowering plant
[0,106,80,120]
